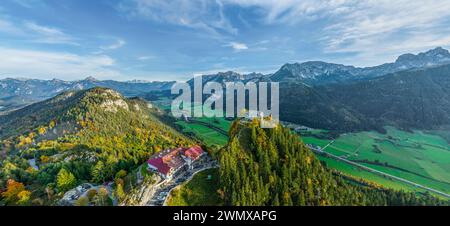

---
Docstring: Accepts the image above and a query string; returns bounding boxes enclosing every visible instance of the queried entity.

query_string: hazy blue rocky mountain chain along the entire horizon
[0,47,450,100]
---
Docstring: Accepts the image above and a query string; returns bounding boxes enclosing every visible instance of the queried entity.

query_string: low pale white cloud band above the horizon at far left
[0,47,120,80]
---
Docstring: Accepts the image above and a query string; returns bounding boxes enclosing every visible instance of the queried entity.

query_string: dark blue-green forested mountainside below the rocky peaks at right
[280,65,450,132]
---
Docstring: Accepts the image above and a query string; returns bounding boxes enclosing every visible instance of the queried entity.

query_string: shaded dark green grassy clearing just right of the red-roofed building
[167,169,221,206]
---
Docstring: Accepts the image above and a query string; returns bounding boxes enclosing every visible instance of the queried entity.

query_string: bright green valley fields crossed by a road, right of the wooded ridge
[302,127,450,197]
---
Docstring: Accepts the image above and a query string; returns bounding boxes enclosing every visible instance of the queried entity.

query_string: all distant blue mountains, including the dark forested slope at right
[0,47,450,131]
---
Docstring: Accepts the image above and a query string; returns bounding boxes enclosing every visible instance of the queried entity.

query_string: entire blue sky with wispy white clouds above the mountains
[0,0,450,81]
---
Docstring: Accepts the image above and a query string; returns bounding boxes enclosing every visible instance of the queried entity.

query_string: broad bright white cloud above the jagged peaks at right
[314,0,450,64]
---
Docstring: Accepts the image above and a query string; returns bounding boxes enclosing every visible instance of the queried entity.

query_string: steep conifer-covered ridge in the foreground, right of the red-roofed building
[220,120,448,206]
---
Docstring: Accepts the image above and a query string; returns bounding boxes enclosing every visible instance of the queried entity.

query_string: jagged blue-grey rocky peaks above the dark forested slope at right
[183,47,450,86]
